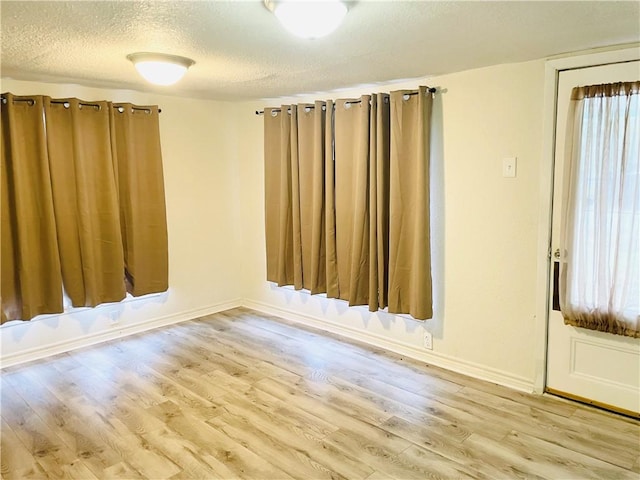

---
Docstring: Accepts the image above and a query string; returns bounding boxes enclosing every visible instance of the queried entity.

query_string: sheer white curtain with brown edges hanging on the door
[560,82,640,337]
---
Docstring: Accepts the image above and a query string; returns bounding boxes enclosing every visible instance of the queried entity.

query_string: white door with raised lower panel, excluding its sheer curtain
[546,61,640,417]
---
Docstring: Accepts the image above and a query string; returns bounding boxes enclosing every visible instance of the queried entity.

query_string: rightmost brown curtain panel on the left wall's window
[111,103,169,296]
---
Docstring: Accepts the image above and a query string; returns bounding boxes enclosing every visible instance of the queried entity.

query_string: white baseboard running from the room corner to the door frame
[242,300,534,393]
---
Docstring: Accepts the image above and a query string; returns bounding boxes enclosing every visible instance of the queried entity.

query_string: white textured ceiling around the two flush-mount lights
[0,0,640,100]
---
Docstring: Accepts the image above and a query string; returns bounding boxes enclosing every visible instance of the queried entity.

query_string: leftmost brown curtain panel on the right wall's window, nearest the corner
[264,105,294,286]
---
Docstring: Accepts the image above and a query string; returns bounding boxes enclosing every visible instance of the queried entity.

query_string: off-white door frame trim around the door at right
[533,43,640,394]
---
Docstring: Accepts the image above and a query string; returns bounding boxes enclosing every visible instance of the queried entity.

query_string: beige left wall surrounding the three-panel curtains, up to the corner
[0,79,241,365]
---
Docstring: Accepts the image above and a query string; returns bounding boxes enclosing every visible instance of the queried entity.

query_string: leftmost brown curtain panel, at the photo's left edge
[0,93,63,323]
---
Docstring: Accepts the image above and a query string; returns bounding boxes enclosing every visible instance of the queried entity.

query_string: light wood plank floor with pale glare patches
[0,309,640,480]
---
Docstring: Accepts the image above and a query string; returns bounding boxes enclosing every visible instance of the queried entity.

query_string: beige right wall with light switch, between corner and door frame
[239,60,544,390]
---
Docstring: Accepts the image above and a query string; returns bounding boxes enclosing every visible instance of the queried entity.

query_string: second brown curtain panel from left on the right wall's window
[291,102,326,293]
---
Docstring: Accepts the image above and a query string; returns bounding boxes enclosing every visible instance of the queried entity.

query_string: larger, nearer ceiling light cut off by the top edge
[264,0,347,38]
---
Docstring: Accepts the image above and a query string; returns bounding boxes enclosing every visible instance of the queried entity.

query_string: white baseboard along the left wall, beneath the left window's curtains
[0,299,242,368]
